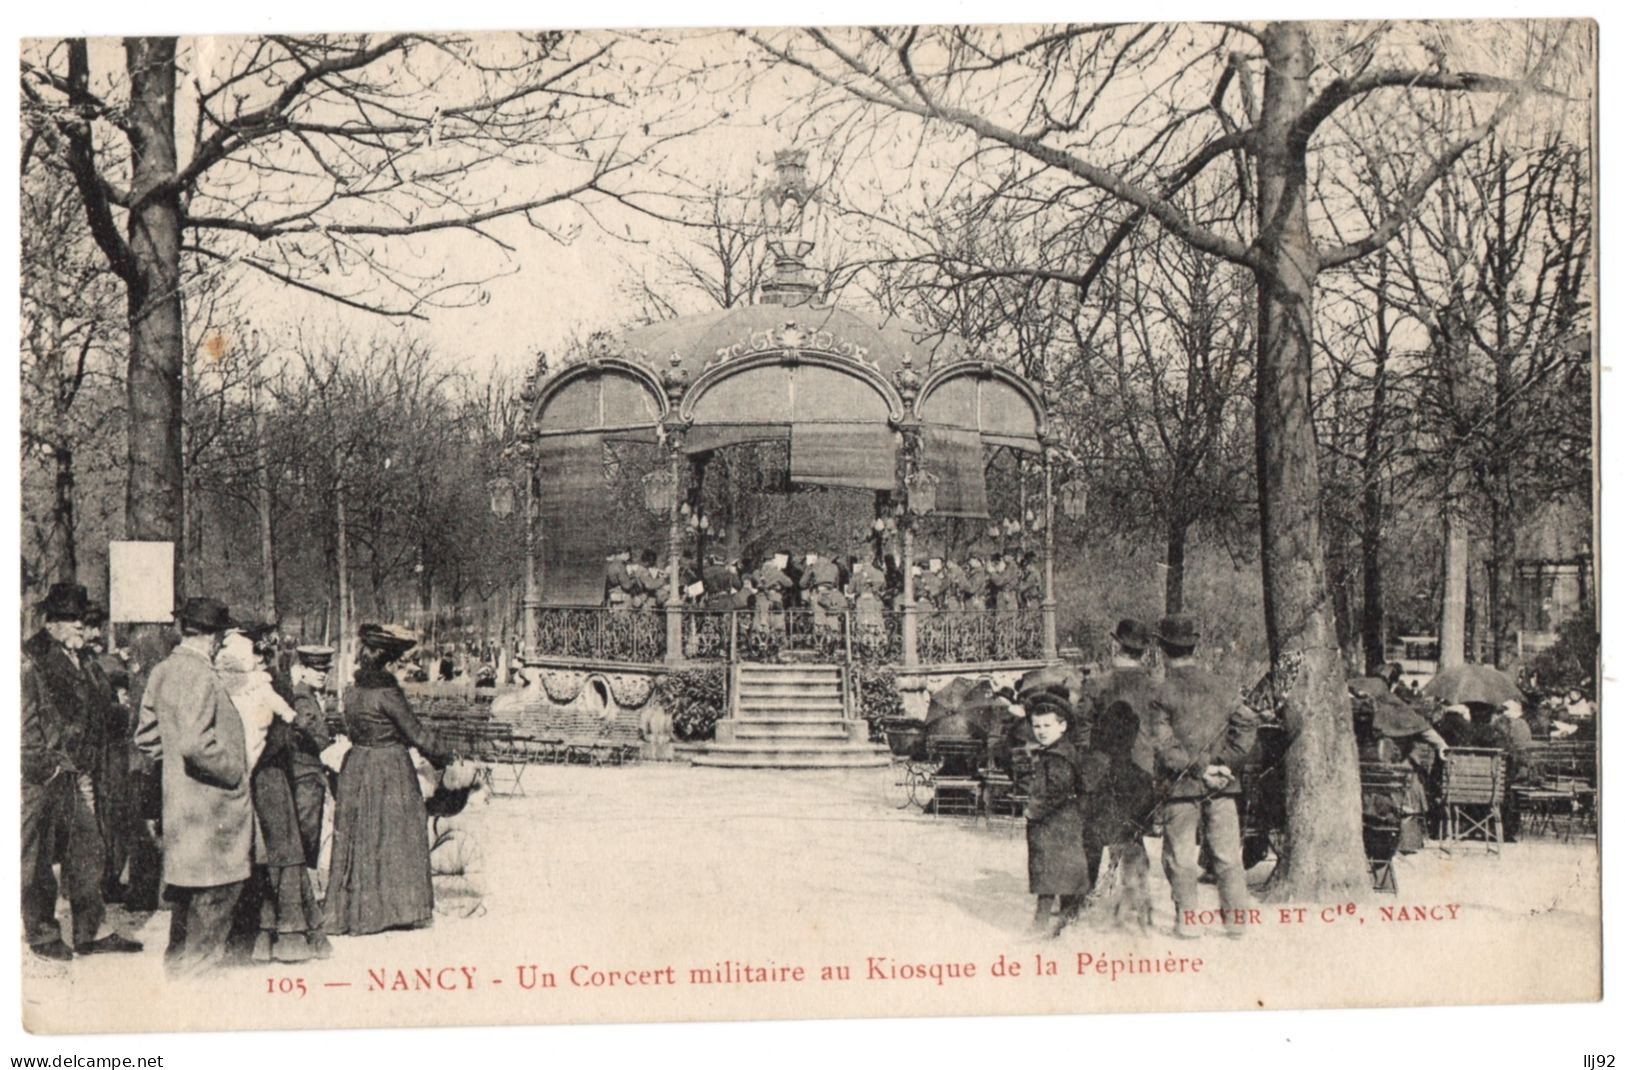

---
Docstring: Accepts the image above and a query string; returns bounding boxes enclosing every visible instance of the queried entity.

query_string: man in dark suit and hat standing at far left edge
[21,584,141,961]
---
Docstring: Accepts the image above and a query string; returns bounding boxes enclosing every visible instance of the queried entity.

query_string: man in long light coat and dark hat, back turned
[135,598,254,979]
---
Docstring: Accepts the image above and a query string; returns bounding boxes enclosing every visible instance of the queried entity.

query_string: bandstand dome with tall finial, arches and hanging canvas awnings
[525,150,1047,605]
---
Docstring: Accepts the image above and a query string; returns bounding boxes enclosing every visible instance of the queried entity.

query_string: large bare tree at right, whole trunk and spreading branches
[748,23,1589,898]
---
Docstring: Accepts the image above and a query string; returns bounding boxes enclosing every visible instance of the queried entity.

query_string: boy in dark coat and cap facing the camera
[1027,694,1089,935]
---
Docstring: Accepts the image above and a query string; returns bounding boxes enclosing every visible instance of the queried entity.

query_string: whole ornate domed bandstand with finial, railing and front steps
[507,153,1058,768]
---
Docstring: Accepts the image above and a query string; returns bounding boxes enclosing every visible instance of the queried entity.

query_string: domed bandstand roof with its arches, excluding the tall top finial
[531,302,1045,452]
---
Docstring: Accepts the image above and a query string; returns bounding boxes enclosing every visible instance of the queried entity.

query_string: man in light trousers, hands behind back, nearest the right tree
[1151,613,1258,938]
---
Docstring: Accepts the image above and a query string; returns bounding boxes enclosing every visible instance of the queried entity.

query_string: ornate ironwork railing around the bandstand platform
[536,605,1043,665]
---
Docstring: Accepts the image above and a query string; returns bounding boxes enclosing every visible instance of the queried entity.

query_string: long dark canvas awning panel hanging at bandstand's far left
[536,434,609,607]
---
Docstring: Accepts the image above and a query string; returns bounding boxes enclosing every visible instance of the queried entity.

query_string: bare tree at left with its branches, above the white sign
[21,33,692,582]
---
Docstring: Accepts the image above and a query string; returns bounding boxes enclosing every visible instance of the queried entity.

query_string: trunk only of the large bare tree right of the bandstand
[1256,23,1370,901]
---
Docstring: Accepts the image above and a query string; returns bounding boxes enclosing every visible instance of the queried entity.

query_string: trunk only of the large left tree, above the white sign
[124,37,184,582]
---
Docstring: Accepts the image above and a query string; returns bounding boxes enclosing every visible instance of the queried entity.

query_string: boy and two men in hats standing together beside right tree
[1001,615,1259,938]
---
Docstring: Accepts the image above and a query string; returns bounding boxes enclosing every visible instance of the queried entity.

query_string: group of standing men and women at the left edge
[21,584,458,979]
